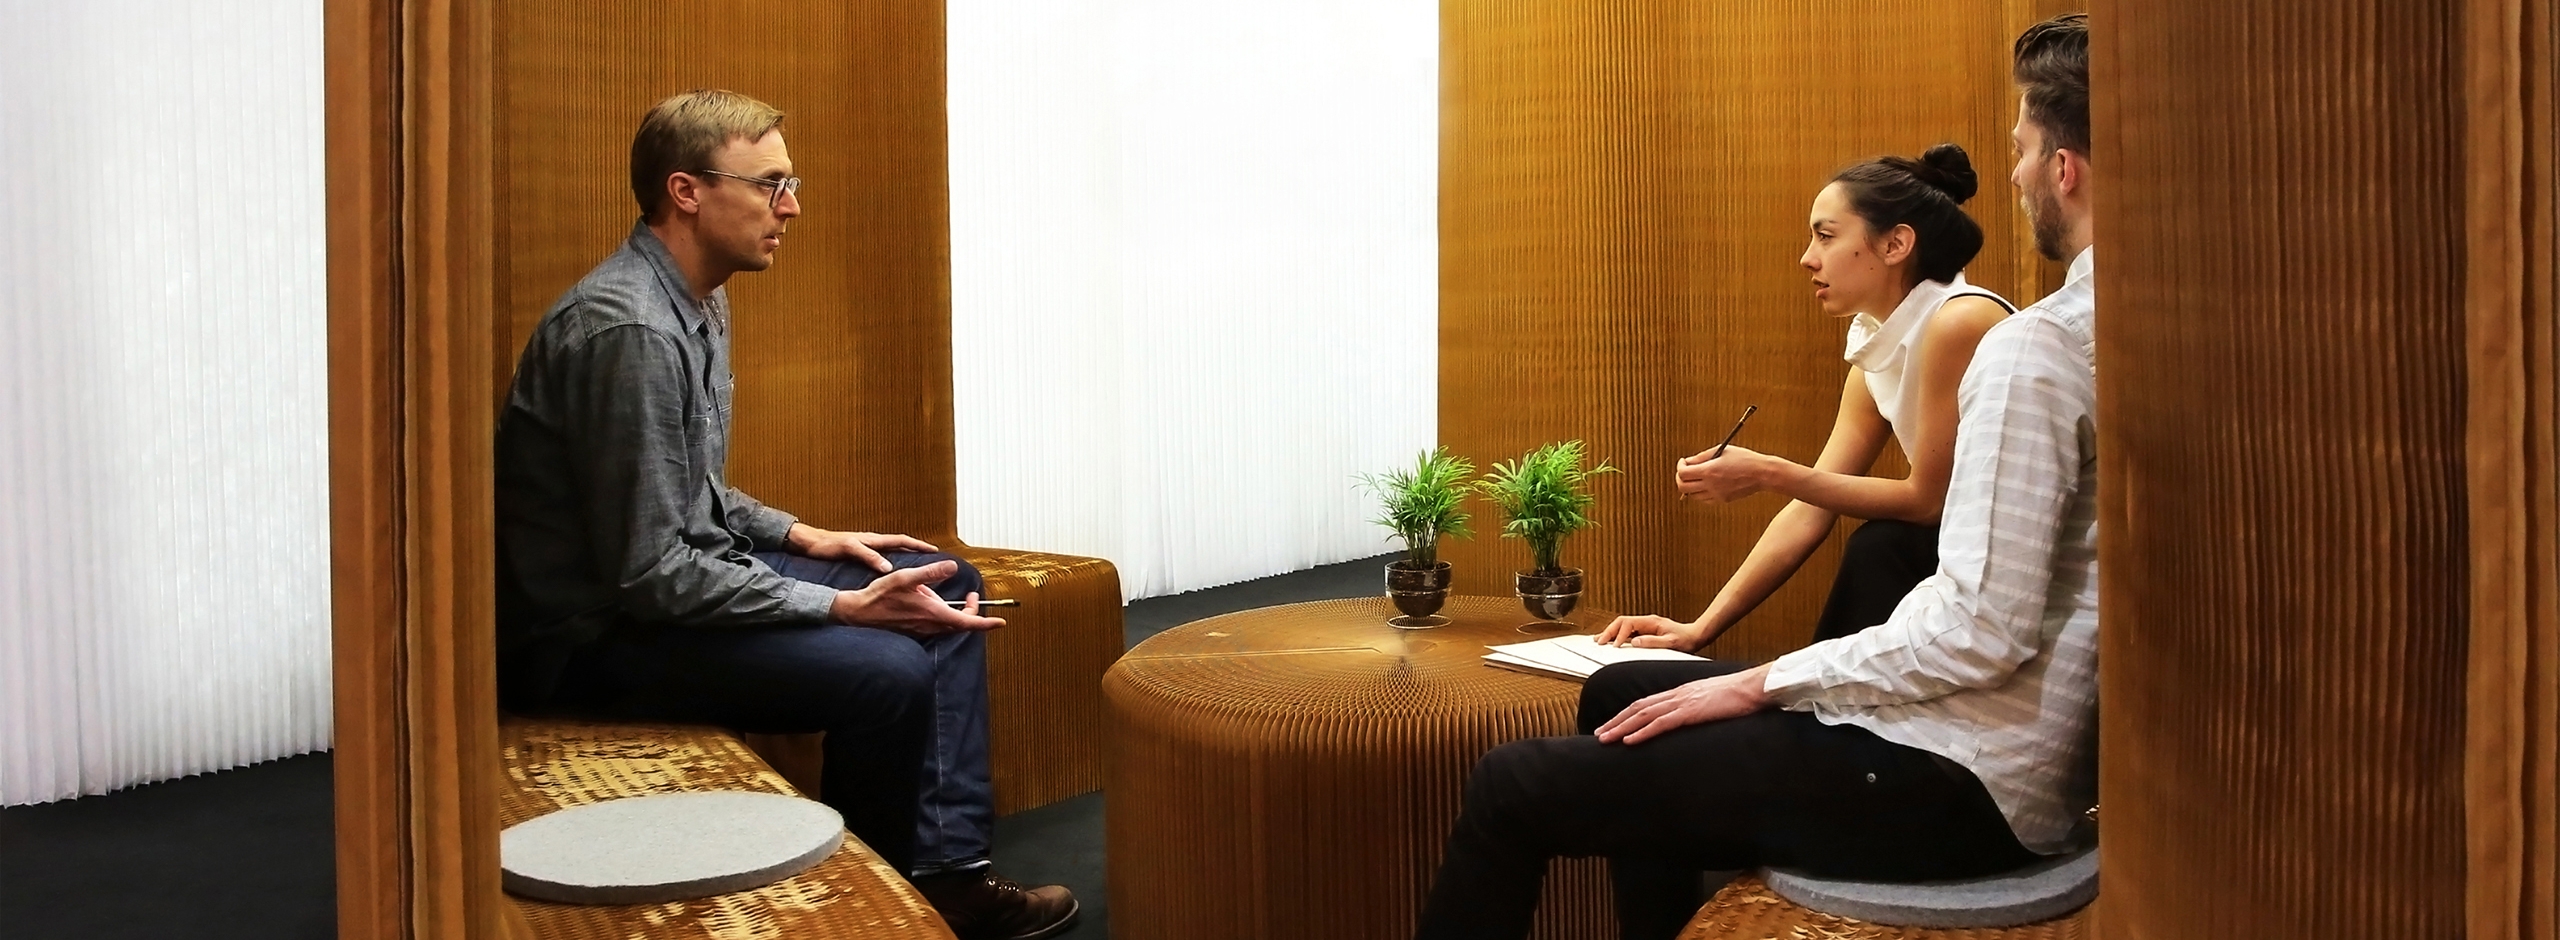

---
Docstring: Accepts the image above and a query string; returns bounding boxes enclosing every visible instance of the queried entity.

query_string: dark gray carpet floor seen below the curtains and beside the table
[0,558,1390,940]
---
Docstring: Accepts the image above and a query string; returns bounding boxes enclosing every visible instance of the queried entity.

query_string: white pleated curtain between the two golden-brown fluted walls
[950,0,1439,597]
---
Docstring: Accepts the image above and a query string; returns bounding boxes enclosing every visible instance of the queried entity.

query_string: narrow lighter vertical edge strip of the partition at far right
[2458,0,2560,940]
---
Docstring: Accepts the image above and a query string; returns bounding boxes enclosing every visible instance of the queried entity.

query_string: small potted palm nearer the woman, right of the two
[1475,441,1618,620]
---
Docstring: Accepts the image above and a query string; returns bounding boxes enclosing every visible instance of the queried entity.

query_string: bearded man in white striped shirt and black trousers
[1418,13,2097,940]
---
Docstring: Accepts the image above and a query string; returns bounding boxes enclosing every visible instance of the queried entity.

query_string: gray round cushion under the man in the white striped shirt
[1761,848,2097,930]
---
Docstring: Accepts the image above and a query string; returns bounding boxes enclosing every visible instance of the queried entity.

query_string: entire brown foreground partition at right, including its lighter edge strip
[2092,0,2560,940]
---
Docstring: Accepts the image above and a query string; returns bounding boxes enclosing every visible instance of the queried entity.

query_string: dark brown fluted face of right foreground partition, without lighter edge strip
[2092,0,2468,940]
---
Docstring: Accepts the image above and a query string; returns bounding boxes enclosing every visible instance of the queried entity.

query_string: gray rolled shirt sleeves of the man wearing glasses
[566,323,835,628]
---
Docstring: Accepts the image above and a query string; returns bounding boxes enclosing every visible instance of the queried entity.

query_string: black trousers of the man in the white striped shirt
[1416,663,2035,940]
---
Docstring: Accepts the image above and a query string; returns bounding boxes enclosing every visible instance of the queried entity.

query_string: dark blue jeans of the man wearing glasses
[561,551,996,876]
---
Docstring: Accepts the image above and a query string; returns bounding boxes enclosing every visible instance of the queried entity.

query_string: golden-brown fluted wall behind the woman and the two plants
[1439,0,2058,656]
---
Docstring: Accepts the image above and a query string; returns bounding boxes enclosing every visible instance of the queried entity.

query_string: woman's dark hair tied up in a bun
[1830,143,1981,282]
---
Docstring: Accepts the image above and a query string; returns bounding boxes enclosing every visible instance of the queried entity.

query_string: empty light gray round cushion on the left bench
[499,789,845,904]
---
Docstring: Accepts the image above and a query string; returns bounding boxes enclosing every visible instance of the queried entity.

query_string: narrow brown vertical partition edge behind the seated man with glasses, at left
[323,0,530,937]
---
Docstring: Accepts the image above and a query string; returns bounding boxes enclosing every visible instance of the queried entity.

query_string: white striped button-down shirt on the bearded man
[1766,248,2097,853]
